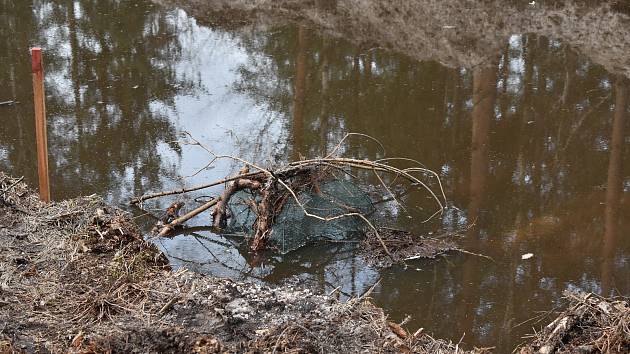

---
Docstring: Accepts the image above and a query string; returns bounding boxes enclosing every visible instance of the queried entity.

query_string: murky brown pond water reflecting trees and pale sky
[0,0,630,352]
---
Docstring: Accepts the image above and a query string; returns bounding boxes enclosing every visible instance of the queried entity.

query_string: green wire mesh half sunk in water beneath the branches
[226,180,374,253]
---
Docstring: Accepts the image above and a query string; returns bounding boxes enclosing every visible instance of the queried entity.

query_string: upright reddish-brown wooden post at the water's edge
[31,48,50,203]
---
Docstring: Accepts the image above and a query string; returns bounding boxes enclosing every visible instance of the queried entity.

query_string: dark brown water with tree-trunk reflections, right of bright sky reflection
[225,27,630,349]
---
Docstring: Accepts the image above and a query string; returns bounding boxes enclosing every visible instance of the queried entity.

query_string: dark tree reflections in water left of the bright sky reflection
[0,0,195,200]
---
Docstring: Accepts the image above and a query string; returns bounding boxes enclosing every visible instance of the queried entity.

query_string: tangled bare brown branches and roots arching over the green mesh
[139,133,446,260]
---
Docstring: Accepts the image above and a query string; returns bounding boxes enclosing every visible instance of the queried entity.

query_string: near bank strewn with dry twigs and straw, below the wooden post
[0,175,474,353]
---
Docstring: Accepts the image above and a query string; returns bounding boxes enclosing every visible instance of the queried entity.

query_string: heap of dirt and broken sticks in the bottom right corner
[520,291,630,354]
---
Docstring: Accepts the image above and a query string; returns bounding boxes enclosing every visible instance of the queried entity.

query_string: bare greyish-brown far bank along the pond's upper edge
[154,0,630,77]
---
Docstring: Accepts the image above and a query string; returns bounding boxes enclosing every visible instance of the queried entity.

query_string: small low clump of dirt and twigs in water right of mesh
[360,228,460,267]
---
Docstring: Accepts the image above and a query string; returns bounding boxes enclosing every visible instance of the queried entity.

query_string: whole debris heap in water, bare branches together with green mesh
[131,132,447,263]
